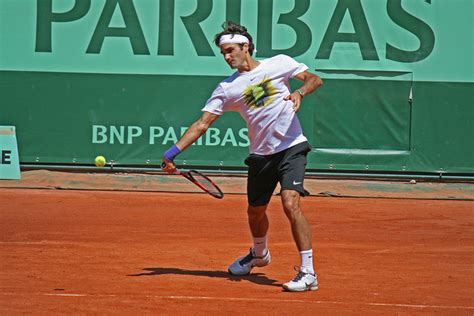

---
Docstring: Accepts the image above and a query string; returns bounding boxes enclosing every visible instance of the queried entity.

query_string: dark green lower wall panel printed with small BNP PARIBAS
[0,72,474,173]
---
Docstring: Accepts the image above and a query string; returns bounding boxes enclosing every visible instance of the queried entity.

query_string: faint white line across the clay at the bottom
[0,293,474,310]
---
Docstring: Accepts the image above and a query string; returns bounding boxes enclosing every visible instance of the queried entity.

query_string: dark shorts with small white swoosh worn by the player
[245,142,311,206]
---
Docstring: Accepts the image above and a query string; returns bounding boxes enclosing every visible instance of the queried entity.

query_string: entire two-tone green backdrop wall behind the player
[0,0,474,174]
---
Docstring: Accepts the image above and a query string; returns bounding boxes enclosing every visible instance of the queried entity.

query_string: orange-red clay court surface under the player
[0,174,474,315]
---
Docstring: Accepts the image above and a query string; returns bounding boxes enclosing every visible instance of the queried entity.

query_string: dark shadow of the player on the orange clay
[128,268,281,286]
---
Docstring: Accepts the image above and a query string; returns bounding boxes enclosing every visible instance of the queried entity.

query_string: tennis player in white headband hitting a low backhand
[163,21,322,292]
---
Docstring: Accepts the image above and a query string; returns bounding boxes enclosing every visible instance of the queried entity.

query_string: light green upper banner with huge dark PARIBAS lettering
[0,0,474,82]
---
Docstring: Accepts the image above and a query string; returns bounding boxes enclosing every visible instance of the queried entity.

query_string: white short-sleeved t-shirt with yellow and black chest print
[202,55,308,155]
